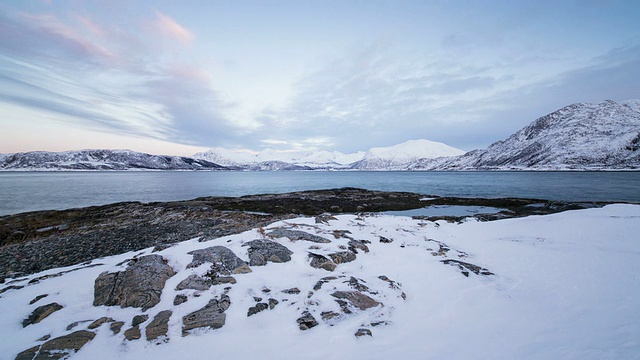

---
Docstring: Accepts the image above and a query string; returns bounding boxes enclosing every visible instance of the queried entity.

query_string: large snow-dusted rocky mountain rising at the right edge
[411,100,640,170]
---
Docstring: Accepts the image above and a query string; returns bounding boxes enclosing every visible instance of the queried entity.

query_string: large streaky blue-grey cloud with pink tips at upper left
[0,13,250,146]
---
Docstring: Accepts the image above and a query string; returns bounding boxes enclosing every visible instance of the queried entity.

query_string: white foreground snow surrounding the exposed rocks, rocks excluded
[0,204,640,359]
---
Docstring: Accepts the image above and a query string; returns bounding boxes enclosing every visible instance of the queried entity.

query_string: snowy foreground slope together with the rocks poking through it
[0,204,640,360]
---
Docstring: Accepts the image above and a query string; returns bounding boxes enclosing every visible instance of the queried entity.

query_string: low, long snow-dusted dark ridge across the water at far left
[0,150,225,170]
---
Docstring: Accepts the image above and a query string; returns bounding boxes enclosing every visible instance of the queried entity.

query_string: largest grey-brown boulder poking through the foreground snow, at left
[93,255,175,311]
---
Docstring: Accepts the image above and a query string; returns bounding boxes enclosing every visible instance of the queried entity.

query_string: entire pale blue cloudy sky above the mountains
[0,0,640,155]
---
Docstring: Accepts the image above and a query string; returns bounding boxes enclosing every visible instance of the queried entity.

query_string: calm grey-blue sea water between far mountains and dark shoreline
[0,171,640,215]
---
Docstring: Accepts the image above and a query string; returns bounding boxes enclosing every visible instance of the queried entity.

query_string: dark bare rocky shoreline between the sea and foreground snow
[0,188,605,283]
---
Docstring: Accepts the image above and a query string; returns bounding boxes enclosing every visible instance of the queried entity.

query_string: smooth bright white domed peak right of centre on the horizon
[351,140,464,170]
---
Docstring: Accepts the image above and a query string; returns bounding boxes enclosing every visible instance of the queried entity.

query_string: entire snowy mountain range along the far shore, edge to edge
[0,100,640,171]
